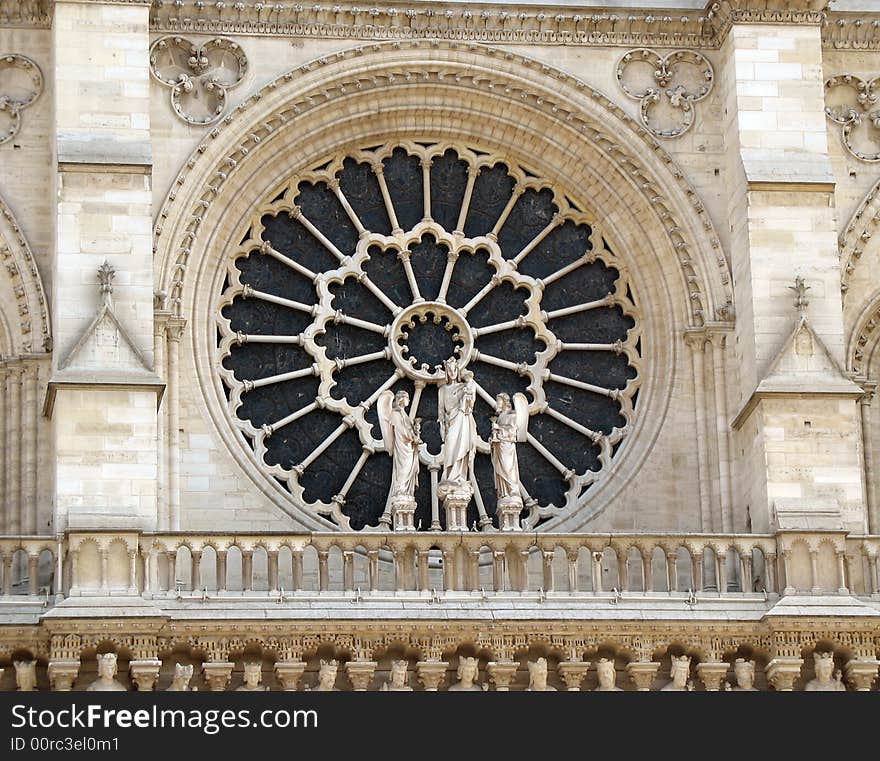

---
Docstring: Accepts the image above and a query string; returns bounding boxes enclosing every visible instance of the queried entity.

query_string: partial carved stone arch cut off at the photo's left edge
[0,191,52,356]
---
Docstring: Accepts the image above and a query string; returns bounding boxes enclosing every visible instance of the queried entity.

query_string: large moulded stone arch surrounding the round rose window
[155,41,733,530]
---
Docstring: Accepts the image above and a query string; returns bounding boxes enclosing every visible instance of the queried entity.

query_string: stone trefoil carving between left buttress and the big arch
[150,36,248,126]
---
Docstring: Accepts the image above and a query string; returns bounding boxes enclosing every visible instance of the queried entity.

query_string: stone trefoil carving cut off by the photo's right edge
[825,74,880,162]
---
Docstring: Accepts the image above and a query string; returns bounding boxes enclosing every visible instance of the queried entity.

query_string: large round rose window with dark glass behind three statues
[217,143,641,529]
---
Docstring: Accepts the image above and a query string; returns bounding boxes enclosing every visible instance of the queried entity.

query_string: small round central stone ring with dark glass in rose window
[391,301,474,383]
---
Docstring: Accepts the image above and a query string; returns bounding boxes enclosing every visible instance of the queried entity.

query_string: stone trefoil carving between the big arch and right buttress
[617,48,715,138]
